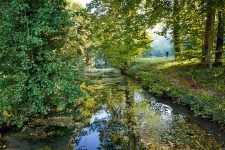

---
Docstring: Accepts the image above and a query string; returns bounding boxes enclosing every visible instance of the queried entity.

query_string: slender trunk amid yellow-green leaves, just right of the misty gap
[173,0,180,59]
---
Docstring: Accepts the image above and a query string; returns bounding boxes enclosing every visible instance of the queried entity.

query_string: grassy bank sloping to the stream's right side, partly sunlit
[127,58,225,124]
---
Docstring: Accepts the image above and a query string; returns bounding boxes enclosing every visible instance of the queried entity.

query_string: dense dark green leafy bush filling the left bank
[0,0,81,127]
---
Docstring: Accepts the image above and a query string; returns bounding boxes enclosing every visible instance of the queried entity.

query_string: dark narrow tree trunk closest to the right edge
[215,11,225,67]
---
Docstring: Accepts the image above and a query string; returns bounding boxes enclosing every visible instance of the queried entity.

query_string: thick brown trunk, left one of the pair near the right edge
[202,1,215,67]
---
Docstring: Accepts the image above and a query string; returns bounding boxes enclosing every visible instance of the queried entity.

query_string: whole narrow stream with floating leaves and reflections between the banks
[0,69,225,150]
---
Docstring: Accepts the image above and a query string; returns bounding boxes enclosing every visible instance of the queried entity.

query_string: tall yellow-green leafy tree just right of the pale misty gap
[158,0,204,60]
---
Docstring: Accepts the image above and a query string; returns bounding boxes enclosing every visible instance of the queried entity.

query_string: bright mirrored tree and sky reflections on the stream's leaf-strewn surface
[74,79,223,150]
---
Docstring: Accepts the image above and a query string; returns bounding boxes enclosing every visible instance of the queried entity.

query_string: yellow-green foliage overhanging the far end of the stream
[88,0,150,66]
